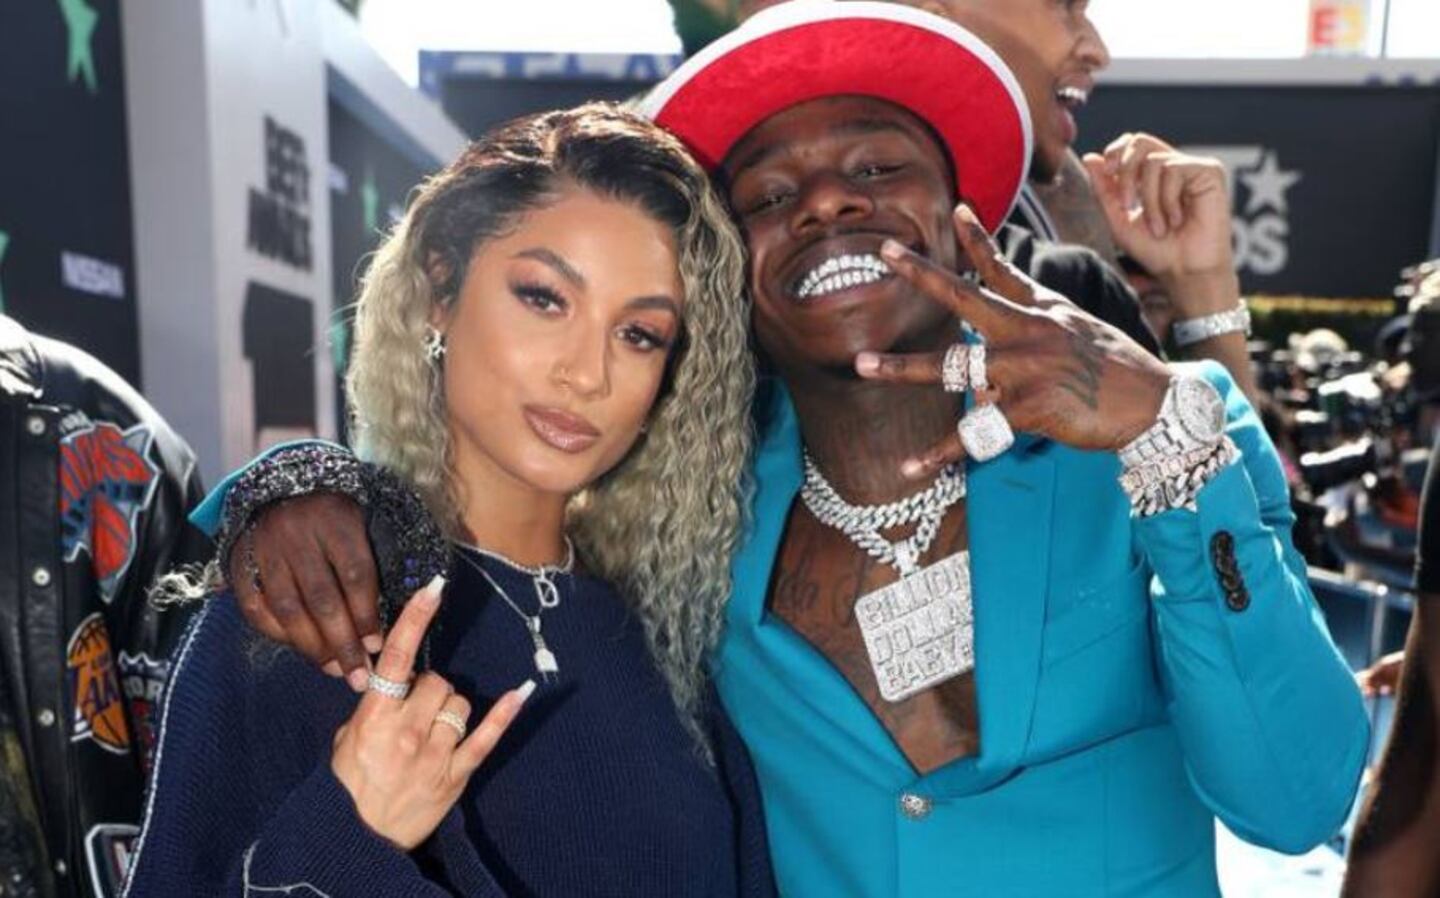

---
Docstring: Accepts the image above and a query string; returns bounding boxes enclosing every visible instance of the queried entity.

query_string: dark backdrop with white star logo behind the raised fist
[1079,83,1440,298]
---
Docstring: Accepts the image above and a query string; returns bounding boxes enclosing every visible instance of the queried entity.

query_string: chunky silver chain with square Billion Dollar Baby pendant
[801,452,975,702]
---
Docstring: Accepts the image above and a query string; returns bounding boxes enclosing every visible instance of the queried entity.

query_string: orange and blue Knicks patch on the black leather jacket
[60,422,160,604]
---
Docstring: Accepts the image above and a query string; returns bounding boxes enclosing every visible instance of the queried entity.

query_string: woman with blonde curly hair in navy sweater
[127,105,773,898]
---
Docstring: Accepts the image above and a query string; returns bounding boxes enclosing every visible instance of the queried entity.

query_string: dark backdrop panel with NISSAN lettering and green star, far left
[0,0,140,383]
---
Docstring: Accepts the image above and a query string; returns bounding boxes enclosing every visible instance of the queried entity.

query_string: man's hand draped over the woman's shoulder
[226,492,383,692]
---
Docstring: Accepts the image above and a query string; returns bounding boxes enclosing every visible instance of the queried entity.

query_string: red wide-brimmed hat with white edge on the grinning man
[641,0,1032,230]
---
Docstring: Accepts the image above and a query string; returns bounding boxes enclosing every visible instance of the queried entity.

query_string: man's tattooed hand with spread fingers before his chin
[855,206,1171,478]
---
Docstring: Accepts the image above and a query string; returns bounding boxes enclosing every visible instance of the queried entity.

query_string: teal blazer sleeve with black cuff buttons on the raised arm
[1135,363,1369,853]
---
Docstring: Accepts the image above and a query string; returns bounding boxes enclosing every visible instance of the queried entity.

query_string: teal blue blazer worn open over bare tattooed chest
[716,364,1368,898]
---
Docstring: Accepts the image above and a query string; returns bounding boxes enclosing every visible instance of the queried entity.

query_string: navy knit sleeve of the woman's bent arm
[125,596,504,898]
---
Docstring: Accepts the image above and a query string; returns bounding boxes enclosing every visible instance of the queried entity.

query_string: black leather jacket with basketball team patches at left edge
[0,315,210,898]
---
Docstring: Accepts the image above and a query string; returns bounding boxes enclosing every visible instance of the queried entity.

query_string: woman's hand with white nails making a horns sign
[330,577,534,851]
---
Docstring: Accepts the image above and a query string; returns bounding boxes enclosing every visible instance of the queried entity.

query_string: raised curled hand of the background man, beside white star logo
[1084,134,1234,279]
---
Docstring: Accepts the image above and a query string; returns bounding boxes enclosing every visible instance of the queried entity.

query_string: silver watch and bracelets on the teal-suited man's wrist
[1119,376,1237,517]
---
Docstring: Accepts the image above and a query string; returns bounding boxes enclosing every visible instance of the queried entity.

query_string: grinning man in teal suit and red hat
[200,3,1368,898]
